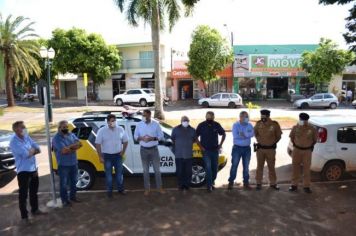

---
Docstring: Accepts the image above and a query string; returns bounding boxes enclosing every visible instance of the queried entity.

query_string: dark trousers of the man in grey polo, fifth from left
[176,158,193,189]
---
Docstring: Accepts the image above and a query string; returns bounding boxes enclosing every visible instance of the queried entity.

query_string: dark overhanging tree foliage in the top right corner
[319,0,356,64]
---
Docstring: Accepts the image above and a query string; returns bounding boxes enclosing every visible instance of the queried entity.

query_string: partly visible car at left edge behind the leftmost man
[0,130,15,178]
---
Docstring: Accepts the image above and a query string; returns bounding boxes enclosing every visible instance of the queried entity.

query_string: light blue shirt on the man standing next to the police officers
[232,121,255,147]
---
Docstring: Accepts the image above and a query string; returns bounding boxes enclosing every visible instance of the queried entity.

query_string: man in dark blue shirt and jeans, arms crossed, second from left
[52,120,82,206]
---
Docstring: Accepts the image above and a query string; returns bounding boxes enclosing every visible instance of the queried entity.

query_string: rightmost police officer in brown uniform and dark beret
[289,113,318,193]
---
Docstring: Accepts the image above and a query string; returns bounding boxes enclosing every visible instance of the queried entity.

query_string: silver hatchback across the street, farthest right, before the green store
[293,93,339,109]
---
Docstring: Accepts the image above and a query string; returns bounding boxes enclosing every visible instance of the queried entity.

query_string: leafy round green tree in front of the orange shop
[187,25,234,91]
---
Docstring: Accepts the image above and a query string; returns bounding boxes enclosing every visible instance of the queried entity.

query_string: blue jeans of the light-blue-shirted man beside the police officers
[229,145,251,184]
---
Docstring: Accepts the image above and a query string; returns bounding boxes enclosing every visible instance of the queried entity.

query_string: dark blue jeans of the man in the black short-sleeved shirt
[203,150,219,188]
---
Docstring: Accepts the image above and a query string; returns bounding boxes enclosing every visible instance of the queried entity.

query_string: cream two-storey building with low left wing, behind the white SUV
[58,42,169,100]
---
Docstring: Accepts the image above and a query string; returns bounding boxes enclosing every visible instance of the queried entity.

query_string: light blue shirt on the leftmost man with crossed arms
[10,134,40,173]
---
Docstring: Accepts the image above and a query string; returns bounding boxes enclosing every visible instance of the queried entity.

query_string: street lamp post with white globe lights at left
[40,46,56,122]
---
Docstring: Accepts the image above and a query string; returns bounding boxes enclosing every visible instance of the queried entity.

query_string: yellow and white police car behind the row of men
[53,111,227,190]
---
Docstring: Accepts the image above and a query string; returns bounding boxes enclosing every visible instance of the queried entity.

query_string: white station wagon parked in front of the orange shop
[198,93,243,108]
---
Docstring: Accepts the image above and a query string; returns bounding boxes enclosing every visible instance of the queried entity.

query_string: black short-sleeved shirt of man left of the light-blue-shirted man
[196,121,225,151]
